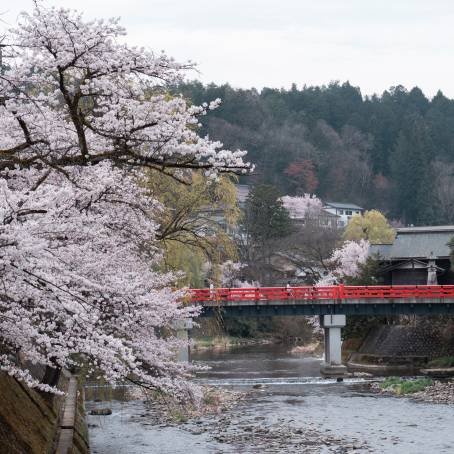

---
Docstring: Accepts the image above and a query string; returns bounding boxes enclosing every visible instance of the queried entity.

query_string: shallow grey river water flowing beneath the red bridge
[87,345,454,454]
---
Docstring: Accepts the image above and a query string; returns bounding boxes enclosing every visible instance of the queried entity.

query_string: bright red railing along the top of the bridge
[189,285,454,303]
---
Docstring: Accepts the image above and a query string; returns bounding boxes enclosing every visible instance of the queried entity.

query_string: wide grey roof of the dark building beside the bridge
[370,225,454,260]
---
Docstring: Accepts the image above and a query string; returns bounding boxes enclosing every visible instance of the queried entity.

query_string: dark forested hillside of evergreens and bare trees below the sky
[178,82,454,225]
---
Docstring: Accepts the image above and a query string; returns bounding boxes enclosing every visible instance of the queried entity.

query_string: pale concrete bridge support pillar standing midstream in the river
[320,314,347,377]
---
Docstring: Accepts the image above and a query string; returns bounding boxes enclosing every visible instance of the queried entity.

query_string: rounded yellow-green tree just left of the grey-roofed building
[343,210,396,244]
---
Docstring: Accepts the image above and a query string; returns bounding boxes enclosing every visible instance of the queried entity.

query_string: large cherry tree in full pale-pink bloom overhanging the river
[0,4,248,395]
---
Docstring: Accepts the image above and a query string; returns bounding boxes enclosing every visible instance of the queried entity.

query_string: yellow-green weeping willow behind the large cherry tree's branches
[142,171,240,287]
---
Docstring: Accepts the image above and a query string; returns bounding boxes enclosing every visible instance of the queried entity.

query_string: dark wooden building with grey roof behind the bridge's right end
[370,225,454,285]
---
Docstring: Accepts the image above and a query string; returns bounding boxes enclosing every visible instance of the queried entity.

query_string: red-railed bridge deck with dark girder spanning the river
[190,285,454,316]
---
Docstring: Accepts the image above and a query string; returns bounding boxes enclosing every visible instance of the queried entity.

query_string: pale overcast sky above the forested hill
[0,0,454,97]
